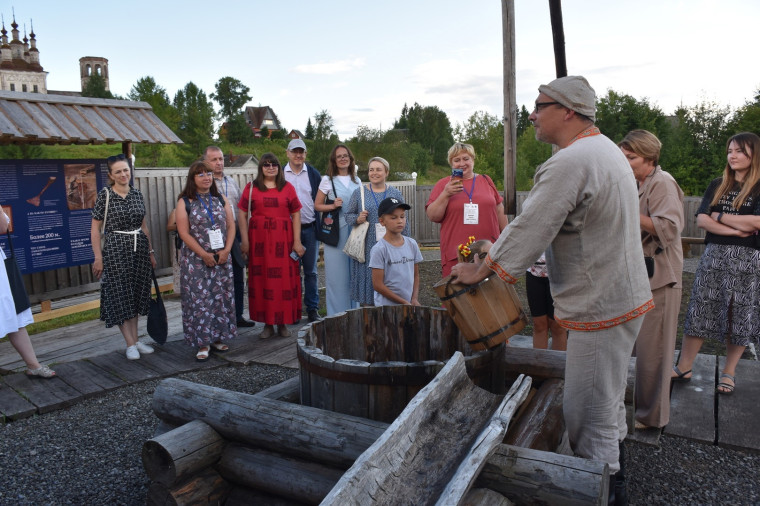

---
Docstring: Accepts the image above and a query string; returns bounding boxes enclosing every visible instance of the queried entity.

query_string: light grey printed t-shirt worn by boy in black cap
[369,236,422,306]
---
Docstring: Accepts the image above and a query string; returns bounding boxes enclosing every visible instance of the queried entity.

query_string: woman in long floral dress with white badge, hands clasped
[176,162,237,362]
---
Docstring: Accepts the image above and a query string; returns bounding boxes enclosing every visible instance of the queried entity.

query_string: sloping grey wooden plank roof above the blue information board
[0,91,182,145]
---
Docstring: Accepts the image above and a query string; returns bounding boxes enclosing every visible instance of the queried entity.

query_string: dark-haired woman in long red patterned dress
[238,153,306,339]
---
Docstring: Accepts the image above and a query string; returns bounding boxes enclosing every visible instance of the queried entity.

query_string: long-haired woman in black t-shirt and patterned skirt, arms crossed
[672,132,760,395]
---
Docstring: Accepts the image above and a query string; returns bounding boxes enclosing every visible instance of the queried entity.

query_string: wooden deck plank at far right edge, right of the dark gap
[716,357,760,451]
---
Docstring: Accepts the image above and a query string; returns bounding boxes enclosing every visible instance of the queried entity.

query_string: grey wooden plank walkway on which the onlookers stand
[0,298,760,451]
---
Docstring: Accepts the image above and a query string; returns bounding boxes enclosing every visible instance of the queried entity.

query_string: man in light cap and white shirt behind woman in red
[283,139,322,322]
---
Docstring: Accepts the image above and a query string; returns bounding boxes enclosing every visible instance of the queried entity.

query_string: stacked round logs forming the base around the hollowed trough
[143,360,609,505]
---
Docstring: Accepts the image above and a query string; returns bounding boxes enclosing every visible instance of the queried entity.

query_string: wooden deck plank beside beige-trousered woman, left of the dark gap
[664,355,717,444]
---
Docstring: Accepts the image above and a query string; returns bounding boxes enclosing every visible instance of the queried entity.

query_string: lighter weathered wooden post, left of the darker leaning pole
[501,0,517,217]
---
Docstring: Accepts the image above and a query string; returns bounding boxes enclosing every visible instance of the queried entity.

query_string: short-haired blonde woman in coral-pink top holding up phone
[425,142,507,277]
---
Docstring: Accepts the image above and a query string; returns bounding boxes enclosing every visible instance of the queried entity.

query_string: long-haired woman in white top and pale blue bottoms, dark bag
[314,144,362,316]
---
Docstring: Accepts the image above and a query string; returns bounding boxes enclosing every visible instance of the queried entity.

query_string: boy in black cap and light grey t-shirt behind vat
[369,197,422,306]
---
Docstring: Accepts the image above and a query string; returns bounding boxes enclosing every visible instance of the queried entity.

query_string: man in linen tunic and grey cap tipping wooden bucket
[452,76,653,504]
